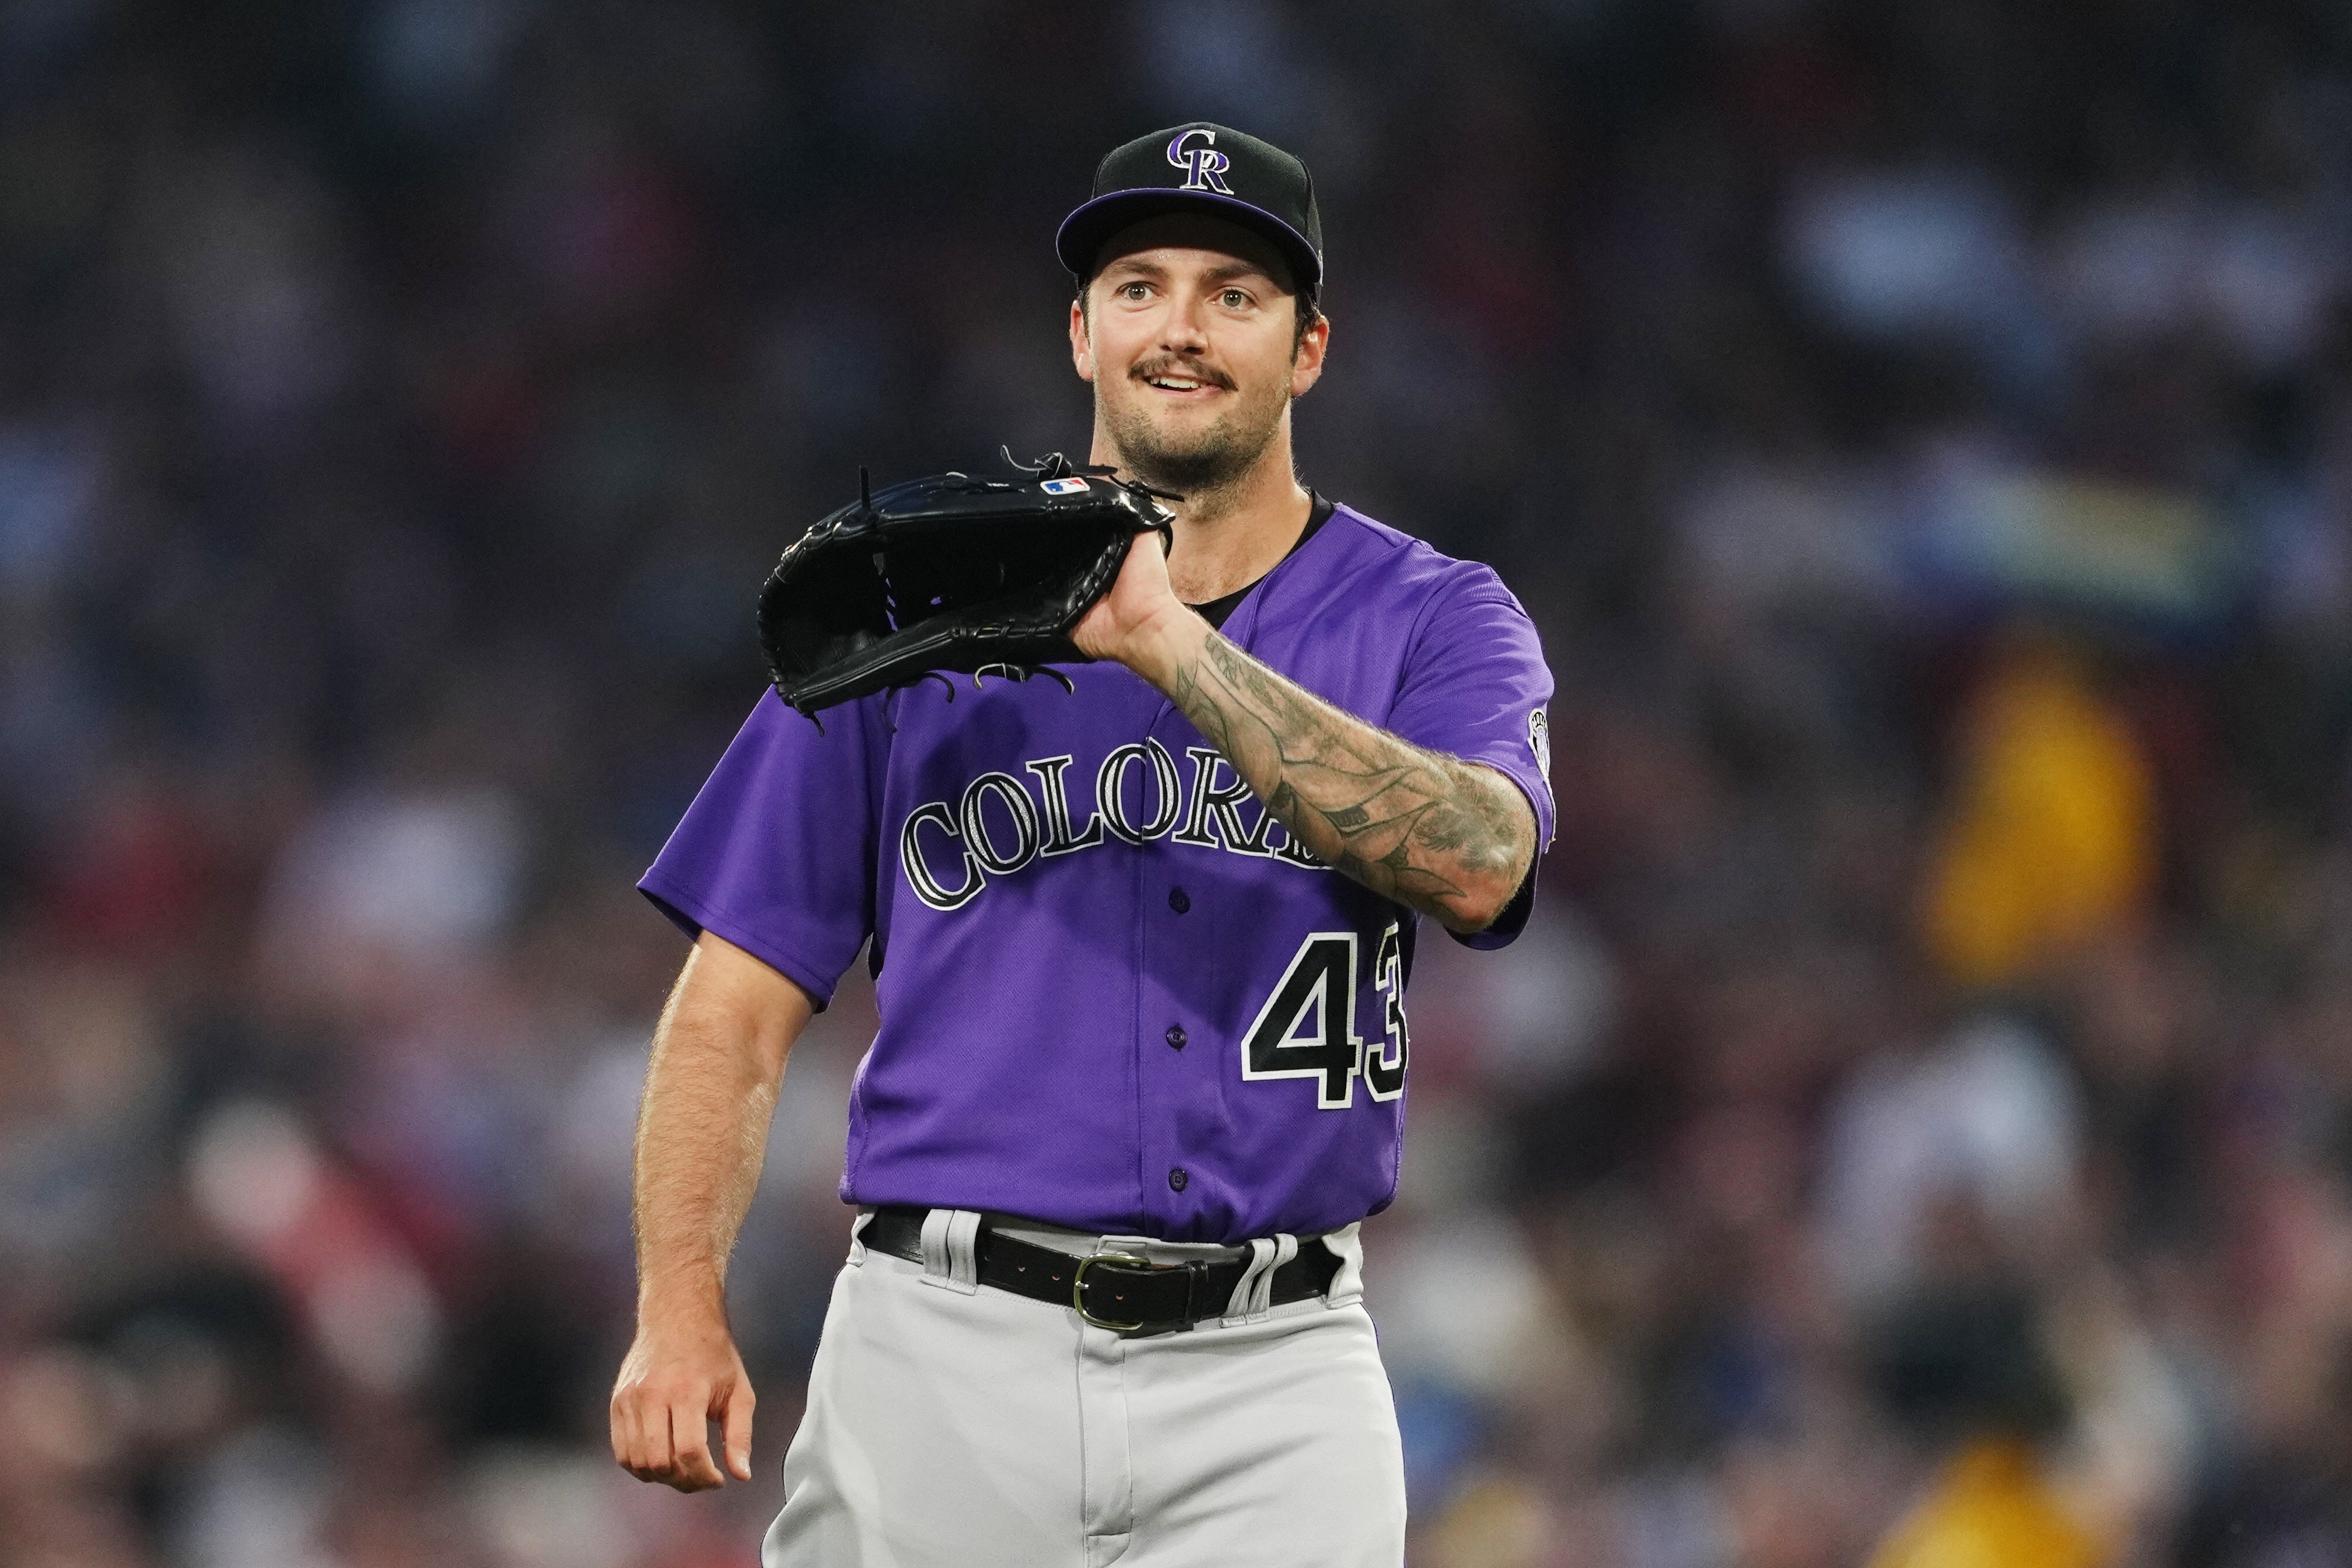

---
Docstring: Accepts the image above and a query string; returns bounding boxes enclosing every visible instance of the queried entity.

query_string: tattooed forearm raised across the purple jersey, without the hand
[1169,632,1536,931]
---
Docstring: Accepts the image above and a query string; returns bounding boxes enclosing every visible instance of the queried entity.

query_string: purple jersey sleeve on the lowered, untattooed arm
[638,691,889,1009]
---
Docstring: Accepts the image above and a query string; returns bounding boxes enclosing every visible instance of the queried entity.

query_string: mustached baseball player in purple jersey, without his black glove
[611,125,1552,1568]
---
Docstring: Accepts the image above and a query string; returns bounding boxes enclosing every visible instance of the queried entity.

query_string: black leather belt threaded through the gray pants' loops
[859,1206,1338,1333]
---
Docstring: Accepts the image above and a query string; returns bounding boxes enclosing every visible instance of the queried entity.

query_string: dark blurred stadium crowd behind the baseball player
[0,0,2352,1568]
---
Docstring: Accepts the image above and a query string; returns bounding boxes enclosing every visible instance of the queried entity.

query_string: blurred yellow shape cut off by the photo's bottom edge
[1870,1438,2110,1568]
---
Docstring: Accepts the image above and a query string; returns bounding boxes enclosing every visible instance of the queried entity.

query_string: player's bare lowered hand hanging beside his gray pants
[611,1314,752,1493]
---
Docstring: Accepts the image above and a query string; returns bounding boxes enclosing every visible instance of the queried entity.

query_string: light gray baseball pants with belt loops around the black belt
[760,1210,1404,1568]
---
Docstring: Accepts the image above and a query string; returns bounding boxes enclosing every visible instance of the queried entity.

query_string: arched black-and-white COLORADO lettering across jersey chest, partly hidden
[898,740,1331,910]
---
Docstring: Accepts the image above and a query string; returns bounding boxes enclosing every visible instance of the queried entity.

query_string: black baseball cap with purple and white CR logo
[1054,120,1322,299]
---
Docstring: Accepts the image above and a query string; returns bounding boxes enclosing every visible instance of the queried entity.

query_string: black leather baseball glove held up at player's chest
[760,452,1178,715]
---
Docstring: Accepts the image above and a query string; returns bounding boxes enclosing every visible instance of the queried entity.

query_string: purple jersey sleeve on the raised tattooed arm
[1388,562,1555,947]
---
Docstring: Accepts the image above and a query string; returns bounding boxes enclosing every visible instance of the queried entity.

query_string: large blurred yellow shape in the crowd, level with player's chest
[1924,646,2157,988]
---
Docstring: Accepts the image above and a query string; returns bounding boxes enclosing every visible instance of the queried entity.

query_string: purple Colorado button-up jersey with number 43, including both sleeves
[640,508,1552,1244]
